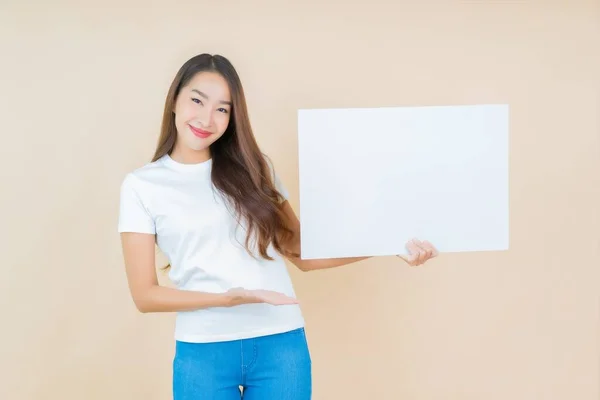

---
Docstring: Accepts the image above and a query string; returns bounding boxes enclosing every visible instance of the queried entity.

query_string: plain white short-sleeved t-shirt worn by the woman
[118,155,304,342]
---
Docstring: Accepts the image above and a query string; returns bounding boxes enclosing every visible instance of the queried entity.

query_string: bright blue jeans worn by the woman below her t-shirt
[173,328,312,400]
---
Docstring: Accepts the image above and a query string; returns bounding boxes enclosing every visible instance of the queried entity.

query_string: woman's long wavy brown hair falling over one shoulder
[152,54,298,260]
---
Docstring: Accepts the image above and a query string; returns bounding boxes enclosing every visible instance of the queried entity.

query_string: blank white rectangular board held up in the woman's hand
[298,104,509,259]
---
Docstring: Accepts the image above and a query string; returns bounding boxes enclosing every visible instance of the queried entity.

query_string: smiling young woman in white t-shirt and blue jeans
[118,54,437,400]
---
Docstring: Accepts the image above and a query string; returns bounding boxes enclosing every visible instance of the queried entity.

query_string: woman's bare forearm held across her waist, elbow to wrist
[134,285,236,313]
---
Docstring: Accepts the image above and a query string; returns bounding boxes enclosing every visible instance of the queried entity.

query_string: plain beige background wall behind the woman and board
[0,0,600,400]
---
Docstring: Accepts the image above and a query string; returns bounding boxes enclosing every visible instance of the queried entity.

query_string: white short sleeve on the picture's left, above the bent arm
[118,174,156,234]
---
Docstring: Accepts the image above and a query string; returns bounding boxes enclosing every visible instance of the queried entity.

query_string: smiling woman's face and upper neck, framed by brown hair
[174,72,231,159]
